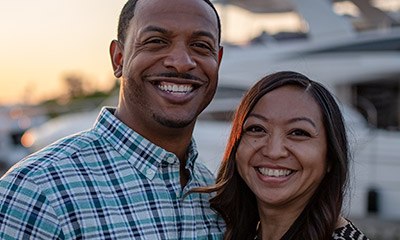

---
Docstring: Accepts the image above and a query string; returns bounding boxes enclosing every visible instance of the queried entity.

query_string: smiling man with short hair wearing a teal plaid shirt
[0,0,224,239]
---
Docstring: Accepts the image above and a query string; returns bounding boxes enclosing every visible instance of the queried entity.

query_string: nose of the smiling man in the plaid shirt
[164,44,197,73]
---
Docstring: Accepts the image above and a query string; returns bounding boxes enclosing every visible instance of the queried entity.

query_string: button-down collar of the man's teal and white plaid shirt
[94,107,198,180]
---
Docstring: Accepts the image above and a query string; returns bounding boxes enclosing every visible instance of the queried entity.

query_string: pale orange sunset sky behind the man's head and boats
[0,0,396,105]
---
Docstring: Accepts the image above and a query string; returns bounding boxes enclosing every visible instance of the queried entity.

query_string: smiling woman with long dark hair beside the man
[200,72,367,240]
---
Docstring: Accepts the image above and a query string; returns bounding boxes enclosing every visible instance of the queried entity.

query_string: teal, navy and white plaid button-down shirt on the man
[0,108,225,239]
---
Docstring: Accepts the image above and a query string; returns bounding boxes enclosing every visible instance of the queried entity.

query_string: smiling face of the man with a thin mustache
[114,0,222,133]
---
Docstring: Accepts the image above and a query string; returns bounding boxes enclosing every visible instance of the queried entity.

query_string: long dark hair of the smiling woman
[195,71,349,240]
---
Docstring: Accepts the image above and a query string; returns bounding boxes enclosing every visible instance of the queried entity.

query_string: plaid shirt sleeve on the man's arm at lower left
[0,172,64,239]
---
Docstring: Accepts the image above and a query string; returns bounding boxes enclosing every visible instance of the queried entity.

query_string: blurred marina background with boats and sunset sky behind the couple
[0,0,400,239]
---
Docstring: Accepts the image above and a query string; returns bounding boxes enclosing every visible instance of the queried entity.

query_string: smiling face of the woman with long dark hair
[236,86,327,209]
